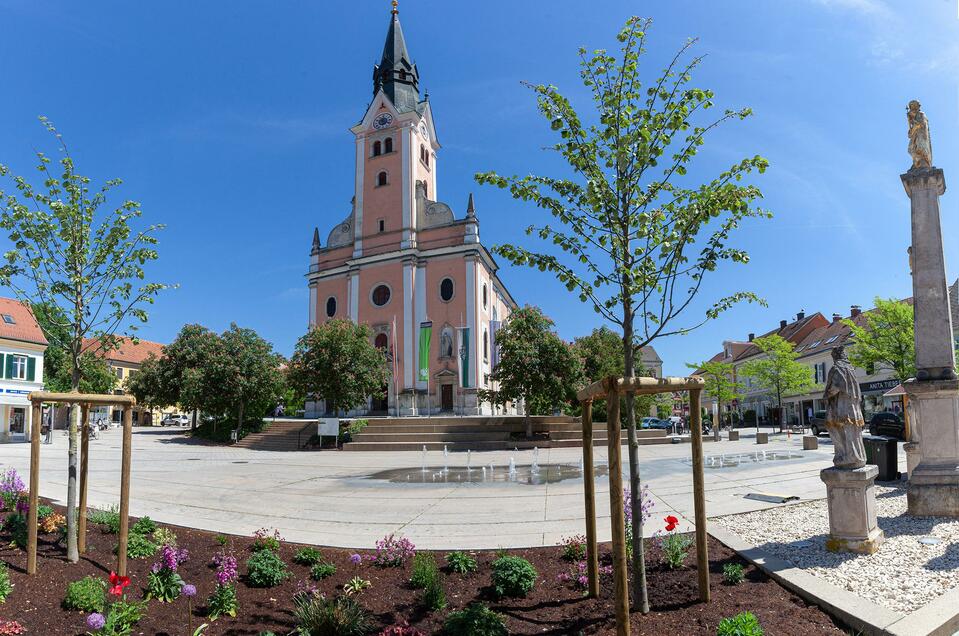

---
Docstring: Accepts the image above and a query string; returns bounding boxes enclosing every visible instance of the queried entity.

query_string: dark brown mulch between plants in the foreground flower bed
[0,504,843,636]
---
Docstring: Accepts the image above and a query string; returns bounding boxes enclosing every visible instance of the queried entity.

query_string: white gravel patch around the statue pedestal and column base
[712,486,959,614]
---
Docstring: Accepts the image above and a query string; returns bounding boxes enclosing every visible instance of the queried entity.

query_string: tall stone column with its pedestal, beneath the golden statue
[901,167,959,517]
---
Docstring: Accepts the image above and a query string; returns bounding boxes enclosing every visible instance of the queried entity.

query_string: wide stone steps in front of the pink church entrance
[343,416,672,451]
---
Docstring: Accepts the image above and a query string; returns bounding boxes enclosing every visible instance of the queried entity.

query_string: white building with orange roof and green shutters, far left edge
[0,298,47,442]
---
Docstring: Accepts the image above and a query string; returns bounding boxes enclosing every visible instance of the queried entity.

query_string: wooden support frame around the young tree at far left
[27,391,137,576]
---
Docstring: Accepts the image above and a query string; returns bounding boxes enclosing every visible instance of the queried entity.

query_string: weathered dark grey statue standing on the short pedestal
[823,346,866,470]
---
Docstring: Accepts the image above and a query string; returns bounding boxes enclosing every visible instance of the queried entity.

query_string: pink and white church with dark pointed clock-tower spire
[307,2,516,416]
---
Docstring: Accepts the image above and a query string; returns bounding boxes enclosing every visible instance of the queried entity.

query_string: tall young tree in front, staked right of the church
[476,17,769,613]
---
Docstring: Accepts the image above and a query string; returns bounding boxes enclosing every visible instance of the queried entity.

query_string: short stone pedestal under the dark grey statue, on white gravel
[819,466,885,554]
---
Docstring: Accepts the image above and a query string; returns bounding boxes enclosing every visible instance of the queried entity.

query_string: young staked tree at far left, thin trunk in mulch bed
[0,117,167,563]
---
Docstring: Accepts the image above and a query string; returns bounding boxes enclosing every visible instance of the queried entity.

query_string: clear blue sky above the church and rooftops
[0,0,959,373]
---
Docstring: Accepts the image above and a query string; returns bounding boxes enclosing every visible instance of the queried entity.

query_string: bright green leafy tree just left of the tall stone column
[843,298,916,382]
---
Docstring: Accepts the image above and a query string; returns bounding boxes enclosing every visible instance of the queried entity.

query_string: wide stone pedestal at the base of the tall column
[903,380,959,517]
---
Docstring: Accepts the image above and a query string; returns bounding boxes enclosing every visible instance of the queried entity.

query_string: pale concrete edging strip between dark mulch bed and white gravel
[709,524,959,636]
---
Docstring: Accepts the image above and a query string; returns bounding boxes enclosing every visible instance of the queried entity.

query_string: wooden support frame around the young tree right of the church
[577,376,710,636]
